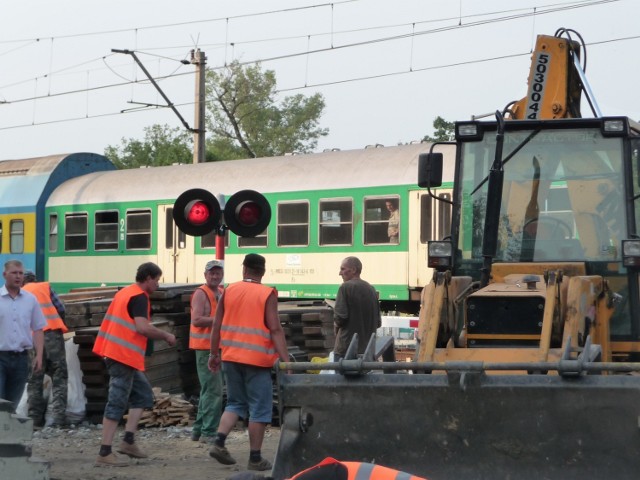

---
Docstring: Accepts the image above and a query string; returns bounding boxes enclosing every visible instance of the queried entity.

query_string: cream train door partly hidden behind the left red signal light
[158,205,195,283]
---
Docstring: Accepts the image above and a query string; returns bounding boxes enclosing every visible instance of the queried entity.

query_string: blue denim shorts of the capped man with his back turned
[222,361,273,423]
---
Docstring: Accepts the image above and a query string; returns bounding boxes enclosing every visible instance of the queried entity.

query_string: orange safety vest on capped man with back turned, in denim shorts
[220,282,278,368]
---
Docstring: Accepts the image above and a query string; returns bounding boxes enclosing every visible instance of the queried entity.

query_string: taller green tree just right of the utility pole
[207,61,329,159]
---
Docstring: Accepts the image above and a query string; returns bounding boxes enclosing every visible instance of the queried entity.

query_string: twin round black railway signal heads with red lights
[173,188,271,237]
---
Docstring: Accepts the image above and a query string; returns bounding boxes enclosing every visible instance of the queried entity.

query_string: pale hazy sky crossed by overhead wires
[0,0,640,160]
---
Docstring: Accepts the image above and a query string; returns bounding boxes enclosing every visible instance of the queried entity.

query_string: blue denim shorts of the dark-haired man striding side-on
[104,358,153,422]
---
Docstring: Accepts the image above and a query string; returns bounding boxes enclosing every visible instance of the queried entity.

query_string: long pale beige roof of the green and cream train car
[47,143,455,205]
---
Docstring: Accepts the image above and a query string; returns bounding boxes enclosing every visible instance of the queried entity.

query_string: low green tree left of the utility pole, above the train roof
[104,124,193,168]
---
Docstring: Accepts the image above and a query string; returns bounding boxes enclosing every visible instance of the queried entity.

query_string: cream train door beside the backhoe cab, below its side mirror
[409,189,452,287]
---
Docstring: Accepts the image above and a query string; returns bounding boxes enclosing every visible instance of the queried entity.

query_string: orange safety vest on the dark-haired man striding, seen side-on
[93,283,151,372]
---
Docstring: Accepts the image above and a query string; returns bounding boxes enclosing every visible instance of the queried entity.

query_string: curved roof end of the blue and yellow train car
[0,153,115,212]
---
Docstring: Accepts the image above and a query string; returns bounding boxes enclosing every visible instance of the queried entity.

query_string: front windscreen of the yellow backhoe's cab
[458,125,626,262]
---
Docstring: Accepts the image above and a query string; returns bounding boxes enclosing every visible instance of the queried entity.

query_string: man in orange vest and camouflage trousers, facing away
[22,270,69,427]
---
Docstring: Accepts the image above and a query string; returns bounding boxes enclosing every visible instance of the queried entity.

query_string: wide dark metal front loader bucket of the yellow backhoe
[273,338,640,480]
